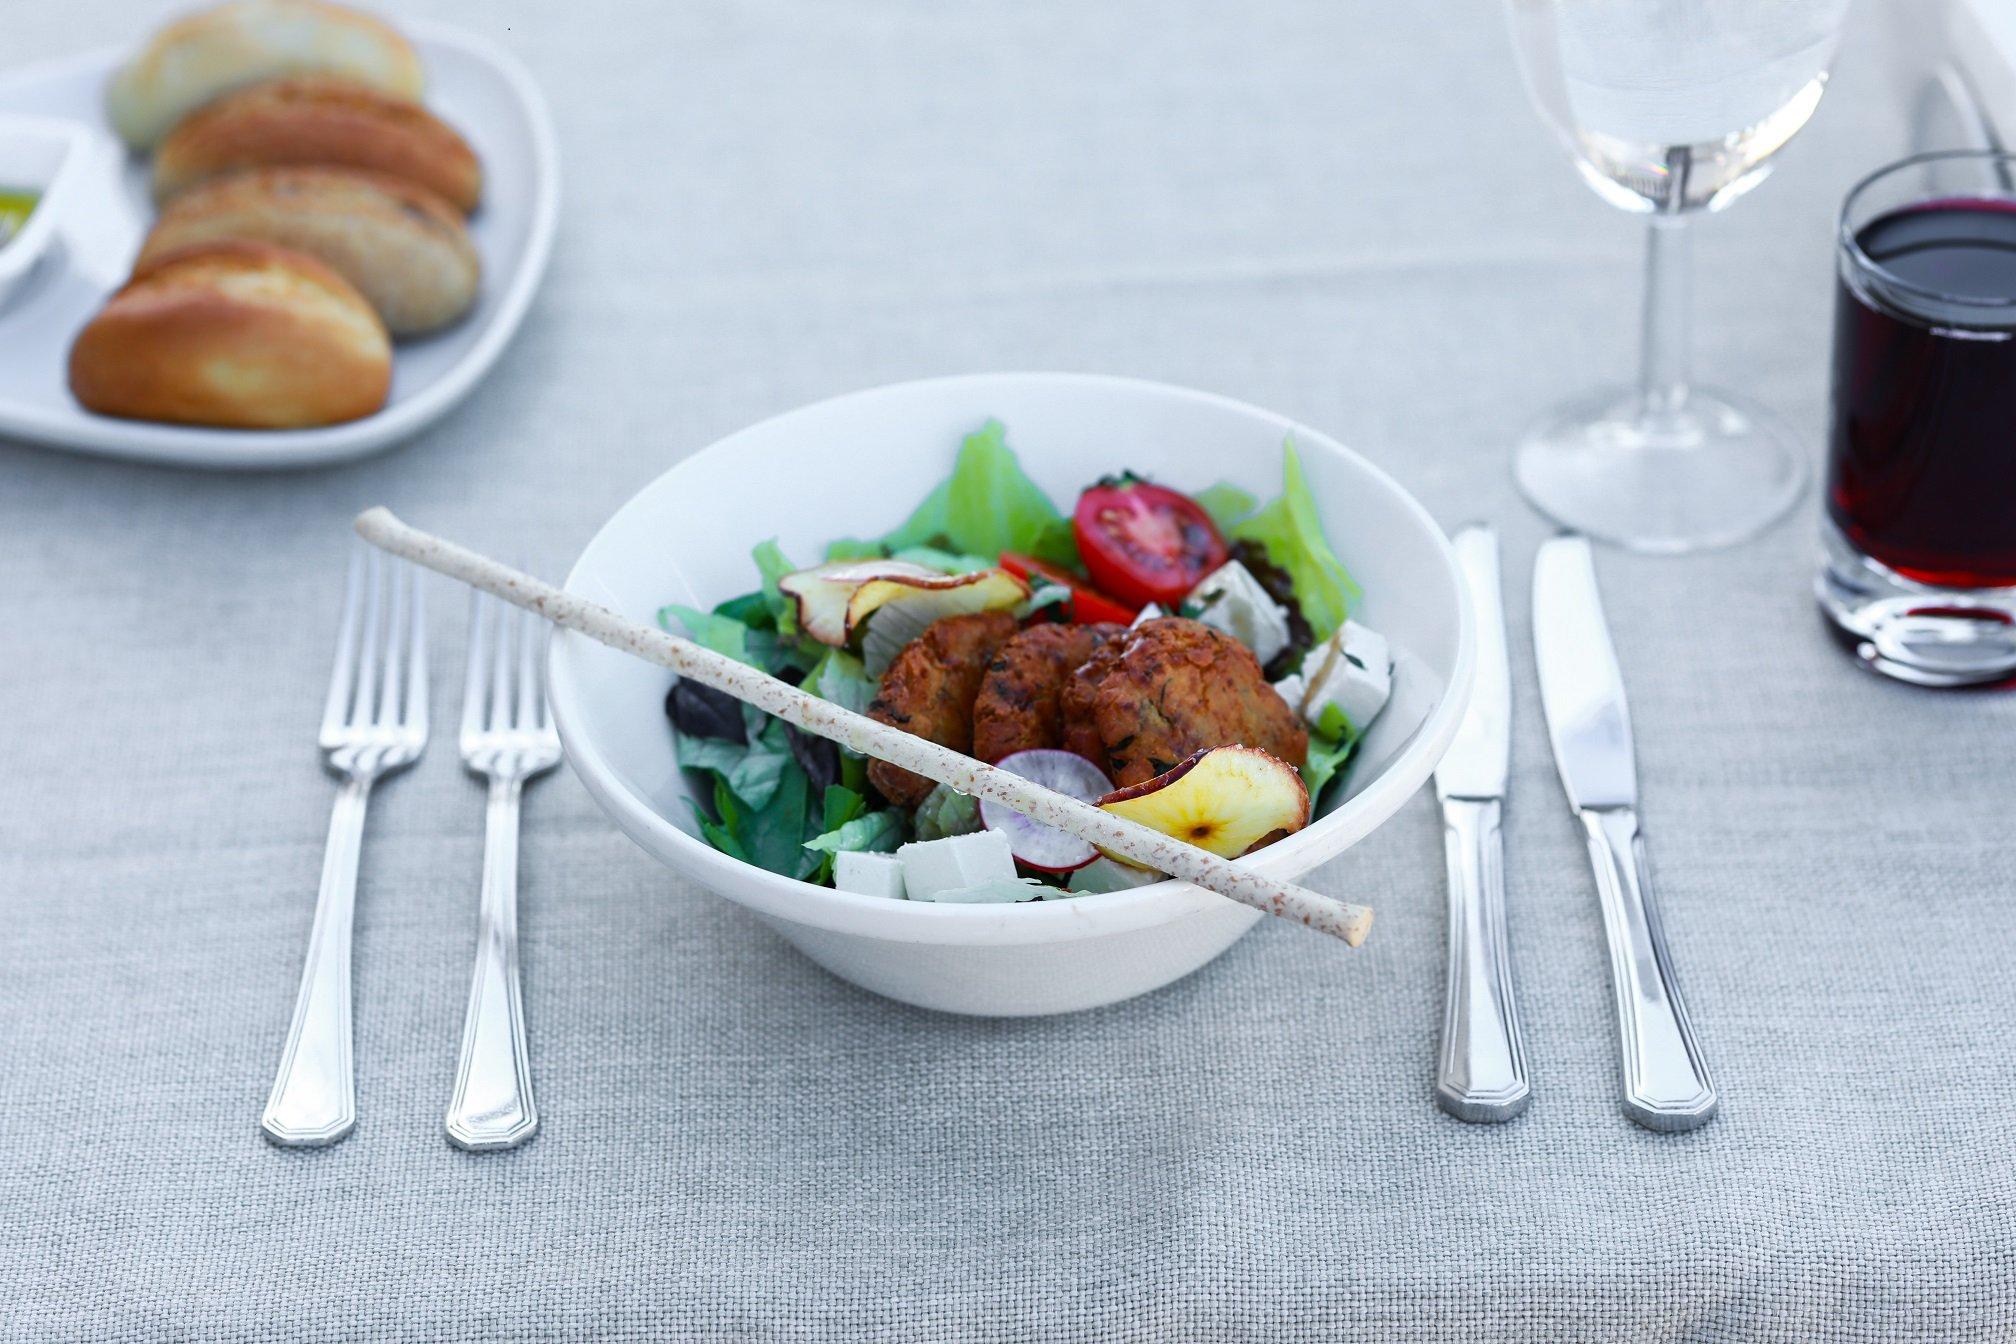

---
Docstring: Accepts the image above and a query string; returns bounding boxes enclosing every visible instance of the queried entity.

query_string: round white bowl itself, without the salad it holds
[550,373,1472,1016]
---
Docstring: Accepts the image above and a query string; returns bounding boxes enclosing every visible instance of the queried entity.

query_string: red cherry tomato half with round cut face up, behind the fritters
[1070,476,1228,611]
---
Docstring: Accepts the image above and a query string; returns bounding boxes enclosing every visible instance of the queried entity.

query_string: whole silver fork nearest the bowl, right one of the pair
[448,592,560,1153]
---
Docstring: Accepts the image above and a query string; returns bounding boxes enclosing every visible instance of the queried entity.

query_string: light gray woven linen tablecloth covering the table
[0,0,2016,1344]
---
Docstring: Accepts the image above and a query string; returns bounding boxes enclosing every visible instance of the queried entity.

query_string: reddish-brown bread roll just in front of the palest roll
[153,75,484,214]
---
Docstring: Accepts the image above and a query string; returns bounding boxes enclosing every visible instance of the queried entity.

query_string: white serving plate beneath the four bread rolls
[0,20,560,469]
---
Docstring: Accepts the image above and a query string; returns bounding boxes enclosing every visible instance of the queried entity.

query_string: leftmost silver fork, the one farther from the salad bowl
[260,542,427,1149]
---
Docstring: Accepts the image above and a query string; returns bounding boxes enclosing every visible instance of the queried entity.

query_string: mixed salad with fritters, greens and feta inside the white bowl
[657,419,1393,903]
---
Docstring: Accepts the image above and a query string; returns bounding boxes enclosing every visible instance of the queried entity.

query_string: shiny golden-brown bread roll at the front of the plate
[71,240,391,429]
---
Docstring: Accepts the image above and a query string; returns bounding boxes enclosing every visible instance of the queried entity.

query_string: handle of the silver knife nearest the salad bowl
[1435,798,1532,1124]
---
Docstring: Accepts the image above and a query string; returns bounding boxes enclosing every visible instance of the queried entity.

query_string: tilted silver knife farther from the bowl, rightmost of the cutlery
[1532,536,1718,1130]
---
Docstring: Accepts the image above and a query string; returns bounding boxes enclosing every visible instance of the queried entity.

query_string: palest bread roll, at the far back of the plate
[105,0,425,149]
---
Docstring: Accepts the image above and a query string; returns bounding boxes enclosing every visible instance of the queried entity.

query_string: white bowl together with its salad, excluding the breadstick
[550,373,1474,1016]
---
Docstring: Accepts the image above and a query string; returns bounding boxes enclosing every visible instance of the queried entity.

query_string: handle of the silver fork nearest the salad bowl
[448,778,538,1153]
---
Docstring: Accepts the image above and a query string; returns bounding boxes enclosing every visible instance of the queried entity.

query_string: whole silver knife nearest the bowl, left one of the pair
[1435,524,1532,1124]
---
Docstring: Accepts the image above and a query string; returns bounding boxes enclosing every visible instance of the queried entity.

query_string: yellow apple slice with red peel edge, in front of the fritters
[1099,748,1308,858]
